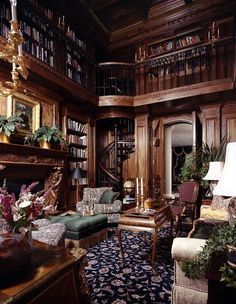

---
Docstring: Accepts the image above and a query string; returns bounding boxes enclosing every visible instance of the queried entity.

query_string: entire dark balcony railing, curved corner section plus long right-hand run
[97,36,234,96]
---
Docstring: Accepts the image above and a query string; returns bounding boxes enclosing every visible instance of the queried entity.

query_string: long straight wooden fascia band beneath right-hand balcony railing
[134,78,233,107]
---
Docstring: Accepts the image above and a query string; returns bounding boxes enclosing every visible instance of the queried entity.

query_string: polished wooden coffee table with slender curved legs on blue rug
[117,204,173,270]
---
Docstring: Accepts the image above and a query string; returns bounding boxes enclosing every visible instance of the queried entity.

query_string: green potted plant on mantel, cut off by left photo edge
[0,115,22,143]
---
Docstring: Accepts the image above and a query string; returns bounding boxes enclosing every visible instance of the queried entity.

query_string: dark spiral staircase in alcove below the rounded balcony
[97,119,135,190]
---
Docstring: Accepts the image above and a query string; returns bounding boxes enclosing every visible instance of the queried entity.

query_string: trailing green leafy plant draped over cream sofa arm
[181,222,236,287]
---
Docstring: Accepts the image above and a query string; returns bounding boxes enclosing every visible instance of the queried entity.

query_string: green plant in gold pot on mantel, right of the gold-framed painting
[34,125,65,149]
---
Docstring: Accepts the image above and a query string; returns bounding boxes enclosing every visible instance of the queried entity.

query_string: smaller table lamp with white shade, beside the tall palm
[203,161,224,197]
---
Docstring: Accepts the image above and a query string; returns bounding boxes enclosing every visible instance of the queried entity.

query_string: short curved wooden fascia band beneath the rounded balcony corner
[99,95,134,107]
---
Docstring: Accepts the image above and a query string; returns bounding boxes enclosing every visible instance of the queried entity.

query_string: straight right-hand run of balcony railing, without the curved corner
[136,37,234,95]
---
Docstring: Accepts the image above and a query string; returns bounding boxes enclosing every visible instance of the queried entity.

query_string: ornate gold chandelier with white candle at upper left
[0,0,29,96]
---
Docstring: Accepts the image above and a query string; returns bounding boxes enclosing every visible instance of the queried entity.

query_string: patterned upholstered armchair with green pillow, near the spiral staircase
[76,187,122,223]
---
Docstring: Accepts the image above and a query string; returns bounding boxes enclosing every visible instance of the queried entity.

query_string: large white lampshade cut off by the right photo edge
[213,142,236,196]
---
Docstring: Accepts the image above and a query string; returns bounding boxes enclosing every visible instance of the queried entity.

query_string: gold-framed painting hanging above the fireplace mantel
[7,93,40,133]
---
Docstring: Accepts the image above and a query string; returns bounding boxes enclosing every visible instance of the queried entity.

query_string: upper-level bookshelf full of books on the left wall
[0,0,96,92]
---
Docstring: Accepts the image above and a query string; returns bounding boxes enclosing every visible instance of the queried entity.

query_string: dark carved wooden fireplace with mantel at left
[0,143,67,210]
